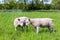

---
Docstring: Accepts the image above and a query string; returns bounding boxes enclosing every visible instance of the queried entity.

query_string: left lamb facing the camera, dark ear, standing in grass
[14,17,30,30]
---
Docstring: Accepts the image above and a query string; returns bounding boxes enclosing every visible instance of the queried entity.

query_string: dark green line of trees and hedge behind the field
[0,0,60,10]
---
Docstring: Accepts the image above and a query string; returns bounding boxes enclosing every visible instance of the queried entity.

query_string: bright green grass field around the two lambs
[0,11,60,40]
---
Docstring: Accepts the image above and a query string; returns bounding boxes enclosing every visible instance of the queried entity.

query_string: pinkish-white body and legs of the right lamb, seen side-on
[30,18,54,33]
